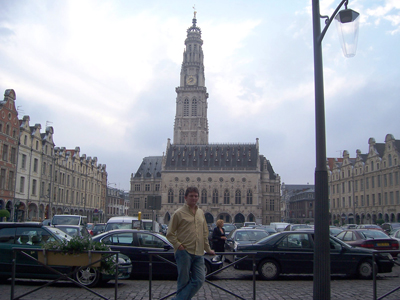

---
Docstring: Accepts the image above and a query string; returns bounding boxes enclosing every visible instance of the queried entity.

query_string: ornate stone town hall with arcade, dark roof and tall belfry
[129,18,280,224]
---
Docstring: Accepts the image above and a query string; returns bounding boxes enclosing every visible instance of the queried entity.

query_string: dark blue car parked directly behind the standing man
[93,229,222,276]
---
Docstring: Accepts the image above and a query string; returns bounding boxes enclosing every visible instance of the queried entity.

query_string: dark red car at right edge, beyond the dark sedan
[336,229,399,257]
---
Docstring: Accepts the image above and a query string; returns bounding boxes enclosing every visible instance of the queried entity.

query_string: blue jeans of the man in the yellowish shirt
[174,250,205,300]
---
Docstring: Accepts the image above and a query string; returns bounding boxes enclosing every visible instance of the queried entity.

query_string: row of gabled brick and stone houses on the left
[0,89,107,221]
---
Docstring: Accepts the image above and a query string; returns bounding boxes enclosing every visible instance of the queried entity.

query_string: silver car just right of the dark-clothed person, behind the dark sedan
[224,227,269,262]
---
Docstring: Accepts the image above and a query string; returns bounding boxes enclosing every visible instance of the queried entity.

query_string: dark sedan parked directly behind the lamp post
[235,231,394,280]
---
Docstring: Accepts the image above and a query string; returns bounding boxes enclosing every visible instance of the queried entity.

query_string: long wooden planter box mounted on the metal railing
[38,251,101,267]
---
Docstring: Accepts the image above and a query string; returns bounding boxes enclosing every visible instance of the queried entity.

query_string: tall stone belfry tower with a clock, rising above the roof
[173,12,208,145]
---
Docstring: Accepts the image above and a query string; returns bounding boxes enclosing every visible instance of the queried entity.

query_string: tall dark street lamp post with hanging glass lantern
[312,0,358,300]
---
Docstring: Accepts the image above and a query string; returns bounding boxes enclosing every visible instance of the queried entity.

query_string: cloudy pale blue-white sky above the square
[0,0,400,190]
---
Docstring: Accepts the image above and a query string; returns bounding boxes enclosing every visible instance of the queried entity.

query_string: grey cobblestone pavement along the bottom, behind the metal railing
[0,267,400,300]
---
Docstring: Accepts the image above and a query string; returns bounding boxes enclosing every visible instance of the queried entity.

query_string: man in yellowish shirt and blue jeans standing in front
[167,187,215,300]
